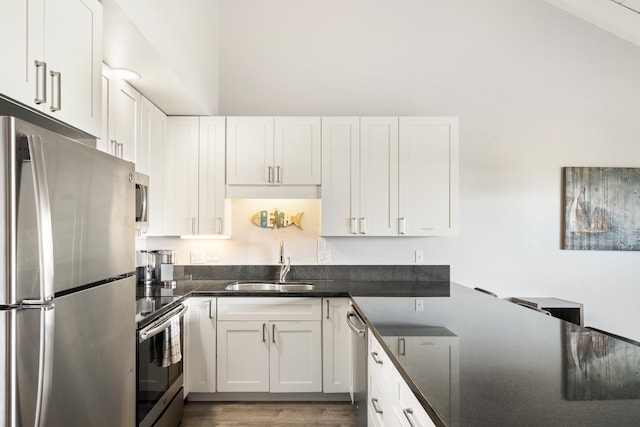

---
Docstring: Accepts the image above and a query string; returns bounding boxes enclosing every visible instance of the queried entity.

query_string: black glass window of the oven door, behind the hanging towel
[137,319,184,423]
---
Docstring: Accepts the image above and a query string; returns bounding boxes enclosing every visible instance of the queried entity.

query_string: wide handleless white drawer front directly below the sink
[218,297,322,320]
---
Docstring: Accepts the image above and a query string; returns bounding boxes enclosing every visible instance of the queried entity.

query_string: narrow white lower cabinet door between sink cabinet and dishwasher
[322,298,352,393]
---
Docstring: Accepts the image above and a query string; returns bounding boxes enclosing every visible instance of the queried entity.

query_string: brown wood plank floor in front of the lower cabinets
[181,402,356,427]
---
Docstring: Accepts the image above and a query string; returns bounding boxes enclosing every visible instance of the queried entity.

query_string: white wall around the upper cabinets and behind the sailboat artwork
[151,0,640,339]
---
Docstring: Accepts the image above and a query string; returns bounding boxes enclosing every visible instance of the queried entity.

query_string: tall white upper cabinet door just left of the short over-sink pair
[198,117,231,235]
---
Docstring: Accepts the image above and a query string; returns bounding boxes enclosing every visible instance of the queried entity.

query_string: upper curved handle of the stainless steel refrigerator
[22,135,54,305]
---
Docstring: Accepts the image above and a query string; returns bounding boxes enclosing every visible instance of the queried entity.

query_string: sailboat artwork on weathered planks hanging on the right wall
[562,167,640,251]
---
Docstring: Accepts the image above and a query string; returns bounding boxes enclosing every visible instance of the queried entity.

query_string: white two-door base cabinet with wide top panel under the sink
[217,297,322,392]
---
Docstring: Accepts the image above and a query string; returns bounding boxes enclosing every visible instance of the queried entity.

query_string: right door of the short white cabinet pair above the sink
[273,117,322,185]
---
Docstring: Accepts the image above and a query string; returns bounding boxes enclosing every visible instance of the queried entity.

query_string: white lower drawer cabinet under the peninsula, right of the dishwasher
[367,331,435,427]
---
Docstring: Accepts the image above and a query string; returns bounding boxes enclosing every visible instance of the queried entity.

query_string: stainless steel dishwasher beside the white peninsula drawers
[347,304,367,427]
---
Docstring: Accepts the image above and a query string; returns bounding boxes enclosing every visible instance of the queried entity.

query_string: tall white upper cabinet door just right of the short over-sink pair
[321,117,360,236]
